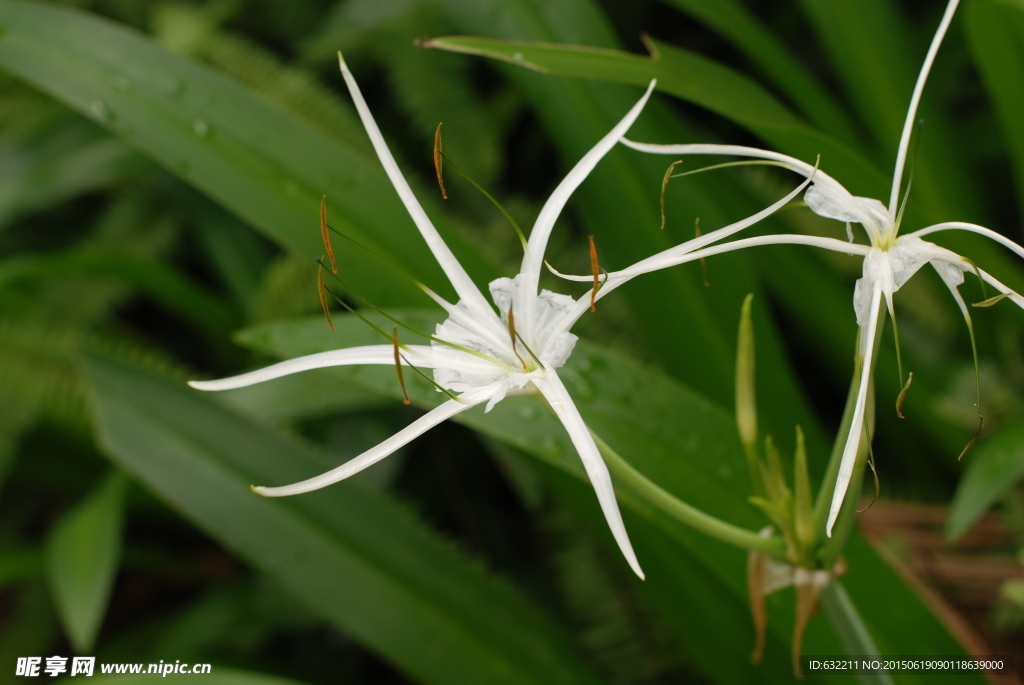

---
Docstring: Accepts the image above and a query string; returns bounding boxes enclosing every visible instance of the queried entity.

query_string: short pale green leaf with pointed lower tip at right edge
[946,422,1024,542]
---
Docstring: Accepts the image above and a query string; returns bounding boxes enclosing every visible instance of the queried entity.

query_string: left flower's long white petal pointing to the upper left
[338,52,490,311]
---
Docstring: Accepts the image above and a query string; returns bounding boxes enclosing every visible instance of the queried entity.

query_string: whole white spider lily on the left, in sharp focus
[189,53,654,579]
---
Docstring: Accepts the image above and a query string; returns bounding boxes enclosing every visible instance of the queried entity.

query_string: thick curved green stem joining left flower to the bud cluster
[590,430,785,559]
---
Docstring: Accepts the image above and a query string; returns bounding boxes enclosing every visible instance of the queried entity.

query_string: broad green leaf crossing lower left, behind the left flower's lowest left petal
[86,357,606,684]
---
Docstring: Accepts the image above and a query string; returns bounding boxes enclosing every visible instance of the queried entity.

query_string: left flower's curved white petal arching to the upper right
[519,80,657,339]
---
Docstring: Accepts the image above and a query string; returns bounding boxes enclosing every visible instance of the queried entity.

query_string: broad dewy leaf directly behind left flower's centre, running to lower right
[238,311,987,682]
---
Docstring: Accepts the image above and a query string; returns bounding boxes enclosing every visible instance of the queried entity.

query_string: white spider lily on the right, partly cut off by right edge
[608,0,1024,537]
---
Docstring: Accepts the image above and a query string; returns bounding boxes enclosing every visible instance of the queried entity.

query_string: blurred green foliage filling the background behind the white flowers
[0,0,1024,685]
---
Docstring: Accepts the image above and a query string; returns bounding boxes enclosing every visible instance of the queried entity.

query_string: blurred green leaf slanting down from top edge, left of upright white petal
[663,0,857,144]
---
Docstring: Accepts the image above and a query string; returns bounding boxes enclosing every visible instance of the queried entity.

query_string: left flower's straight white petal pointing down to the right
[534,371,644,579]
